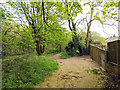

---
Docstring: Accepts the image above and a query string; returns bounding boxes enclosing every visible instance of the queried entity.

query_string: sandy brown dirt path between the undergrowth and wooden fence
[35,54,107,88]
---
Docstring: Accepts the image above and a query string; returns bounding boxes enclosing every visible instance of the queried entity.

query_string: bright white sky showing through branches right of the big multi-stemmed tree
[63,0,118,38]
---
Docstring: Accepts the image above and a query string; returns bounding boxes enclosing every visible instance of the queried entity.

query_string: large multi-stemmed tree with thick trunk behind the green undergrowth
[2,1,65,55]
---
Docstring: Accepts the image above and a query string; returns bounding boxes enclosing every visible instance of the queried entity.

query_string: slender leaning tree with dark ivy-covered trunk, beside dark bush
[65,0,83,55]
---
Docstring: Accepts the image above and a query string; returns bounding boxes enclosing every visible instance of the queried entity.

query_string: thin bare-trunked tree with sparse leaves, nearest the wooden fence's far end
[82,0,118,52]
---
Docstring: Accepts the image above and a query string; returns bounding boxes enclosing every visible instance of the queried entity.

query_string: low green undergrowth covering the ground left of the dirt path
[2,54,58,88]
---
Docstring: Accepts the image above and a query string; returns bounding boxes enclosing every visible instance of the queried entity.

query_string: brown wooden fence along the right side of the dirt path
[90,40,120,75]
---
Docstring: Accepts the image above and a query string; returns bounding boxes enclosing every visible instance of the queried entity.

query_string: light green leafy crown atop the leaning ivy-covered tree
[54,1,83,22]
